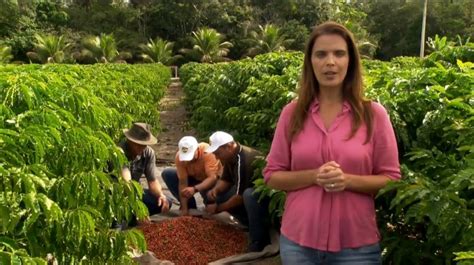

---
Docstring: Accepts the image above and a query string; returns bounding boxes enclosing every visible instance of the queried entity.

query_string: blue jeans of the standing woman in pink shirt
[280,235,382,265]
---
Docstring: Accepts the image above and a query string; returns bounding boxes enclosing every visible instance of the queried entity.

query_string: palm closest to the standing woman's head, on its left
[247,24,293,56]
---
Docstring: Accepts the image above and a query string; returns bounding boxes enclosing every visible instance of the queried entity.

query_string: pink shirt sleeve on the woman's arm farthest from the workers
[372,103,401,180]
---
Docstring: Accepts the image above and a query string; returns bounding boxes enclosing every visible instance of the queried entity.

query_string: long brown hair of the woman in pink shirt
[289,22,373,144]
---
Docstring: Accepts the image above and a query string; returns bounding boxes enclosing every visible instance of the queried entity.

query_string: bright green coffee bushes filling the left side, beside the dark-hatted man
[0,64,171,264]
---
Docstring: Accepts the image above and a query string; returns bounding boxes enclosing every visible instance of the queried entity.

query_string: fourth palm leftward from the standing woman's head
[76,33,131,63]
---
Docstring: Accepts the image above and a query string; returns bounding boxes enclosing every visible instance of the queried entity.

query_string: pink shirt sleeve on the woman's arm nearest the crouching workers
[263,102,296,182]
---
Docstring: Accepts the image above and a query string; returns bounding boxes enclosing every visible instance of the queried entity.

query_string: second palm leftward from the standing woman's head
[180,28,233,63]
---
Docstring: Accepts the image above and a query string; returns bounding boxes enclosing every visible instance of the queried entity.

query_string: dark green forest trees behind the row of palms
[0,0,474,64]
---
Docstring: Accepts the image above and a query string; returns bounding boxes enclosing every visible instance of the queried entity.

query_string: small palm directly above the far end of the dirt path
[139,37,180,65]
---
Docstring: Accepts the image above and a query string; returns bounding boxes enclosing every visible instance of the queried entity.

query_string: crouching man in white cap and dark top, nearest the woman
[206,131,270,252]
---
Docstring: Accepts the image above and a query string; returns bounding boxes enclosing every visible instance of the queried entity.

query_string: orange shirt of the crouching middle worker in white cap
[175,143,222,181]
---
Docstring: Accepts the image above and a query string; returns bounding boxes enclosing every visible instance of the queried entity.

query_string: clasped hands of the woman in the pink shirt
[314,161,348,192]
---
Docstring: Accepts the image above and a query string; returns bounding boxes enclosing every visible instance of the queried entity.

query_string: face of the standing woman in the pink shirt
[311,34,349,90]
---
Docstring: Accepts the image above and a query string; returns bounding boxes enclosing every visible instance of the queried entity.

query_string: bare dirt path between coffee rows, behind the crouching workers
[143,79,281,265]
